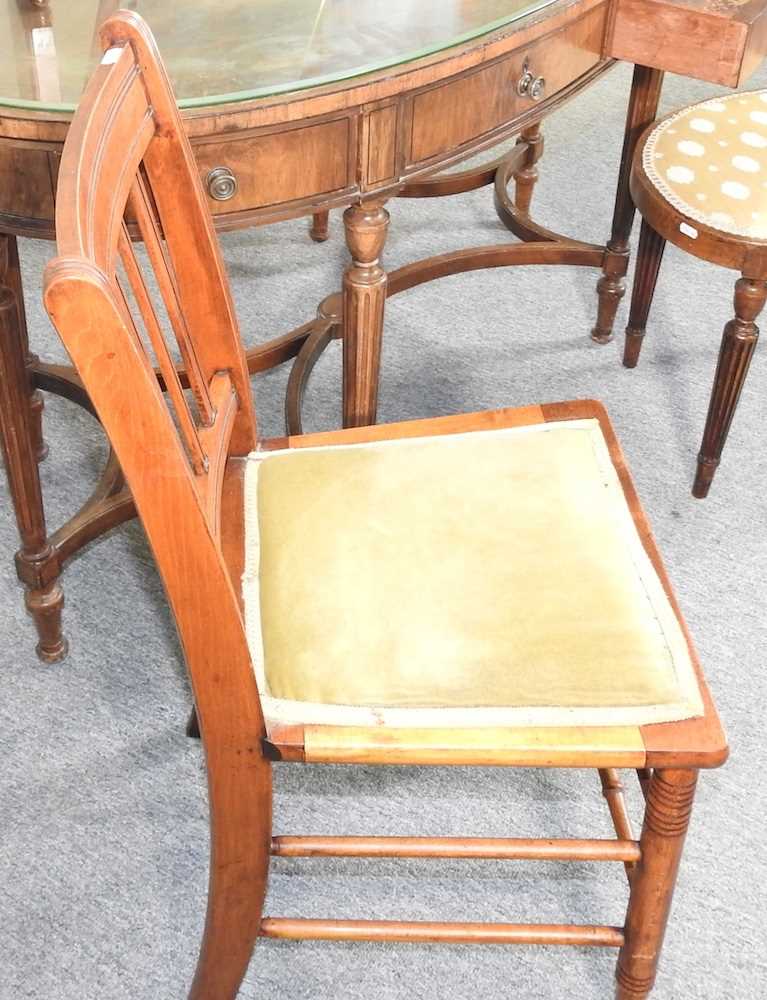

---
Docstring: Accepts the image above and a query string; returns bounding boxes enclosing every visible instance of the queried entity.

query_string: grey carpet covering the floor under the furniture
[0,67,767,1000]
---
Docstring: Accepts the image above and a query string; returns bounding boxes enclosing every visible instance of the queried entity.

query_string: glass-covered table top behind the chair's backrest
[0,0,554,111]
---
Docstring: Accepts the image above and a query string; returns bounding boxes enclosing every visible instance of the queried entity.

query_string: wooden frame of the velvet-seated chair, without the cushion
[43,13,727,1000]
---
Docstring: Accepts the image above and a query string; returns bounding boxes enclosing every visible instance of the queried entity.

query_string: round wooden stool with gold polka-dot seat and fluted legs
[623,91,767,497]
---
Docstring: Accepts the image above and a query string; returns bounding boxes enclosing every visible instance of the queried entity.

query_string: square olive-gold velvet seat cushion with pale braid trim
[243,420,701,727]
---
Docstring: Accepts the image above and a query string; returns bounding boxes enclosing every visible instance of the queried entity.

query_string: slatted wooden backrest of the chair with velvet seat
[45,11,263,754]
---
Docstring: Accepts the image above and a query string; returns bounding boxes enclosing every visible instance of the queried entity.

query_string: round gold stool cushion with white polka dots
[642,90,767,240]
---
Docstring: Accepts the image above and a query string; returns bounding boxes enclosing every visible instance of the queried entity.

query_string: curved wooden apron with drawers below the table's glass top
[0,0,612,238]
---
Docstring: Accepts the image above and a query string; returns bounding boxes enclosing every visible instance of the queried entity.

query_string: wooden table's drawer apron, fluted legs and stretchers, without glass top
[0,0,663,662]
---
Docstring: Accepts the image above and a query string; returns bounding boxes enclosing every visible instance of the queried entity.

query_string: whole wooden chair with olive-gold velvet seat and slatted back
[45,12,727,1000]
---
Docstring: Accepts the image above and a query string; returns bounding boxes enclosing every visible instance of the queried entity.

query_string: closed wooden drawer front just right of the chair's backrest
[192,116,356,215]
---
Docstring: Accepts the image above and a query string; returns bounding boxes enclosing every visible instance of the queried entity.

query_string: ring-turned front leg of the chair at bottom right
[615,770,698,1000]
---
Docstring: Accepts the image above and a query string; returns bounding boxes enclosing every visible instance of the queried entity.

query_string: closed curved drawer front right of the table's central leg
[406,4,608,166]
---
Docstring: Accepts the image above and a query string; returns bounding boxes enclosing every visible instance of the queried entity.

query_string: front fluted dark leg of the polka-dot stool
[692,277,767,499]
